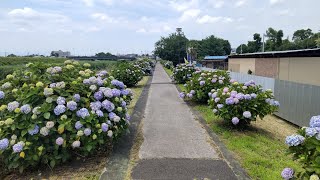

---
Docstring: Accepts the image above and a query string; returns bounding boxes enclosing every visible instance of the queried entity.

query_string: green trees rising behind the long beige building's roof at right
[236,27,320,54]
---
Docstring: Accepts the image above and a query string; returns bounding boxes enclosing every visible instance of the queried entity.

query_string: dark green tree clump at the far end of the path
[154,31,231,64]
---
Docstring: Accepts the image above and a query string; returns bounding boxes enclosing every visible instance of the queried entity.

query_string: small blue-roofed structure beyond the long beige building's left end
[201,56,228,70]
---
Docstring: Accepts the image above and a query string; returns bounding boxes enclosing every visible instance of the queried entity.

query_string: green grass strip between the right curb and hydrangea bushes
[166,69,302,180]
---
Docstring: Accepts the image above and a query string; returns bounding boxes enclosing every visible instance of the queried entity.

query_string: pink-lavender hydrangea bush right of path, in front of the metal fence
[208,81,279,126]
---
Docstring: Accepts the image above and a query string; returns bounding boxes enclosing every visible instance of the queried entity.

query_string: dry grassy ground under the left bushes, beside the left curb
[0,76,150,180]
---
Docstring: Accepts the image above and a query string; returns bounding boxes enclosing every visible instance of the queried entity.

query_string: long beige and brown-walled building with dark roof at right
[228,48,320,86]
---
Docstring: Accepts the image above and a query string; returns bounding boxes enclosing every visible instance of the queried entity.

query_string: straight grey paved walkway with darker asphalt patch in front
[132,64,236,179]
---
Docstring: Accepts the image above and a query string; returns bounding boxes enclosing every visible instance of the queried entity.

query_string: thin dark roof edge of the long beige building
[229,48,320,58]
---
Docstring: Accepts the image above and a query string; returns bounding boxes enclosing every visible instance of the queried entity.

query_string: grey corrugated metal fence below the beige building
[201,68,320,126]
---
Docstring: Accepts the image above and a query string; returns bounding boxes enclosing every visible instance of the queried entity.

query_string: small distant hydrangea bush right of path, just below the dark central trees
[172,64,196,84]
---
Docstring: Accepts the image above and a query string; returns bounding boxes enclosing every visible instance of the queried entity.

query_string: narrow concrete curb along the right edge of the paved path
[175,80,251,180]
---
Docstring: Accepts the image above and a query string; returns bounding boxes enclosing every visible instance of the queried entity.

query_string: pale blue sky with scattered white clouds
[0,0,320,56]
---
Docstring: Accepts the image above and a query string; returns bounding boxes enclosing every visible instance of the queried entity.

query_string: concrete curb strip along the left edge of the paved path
[99,76,153,180]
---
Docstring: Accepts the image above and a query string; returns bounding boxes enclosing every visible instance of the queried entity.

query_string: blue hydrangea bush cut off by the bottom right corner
[281,115,320,180]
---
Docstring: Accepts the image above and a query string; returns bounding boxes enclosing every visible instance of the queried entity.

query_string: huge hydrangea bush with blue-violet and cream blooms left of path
[0,60,132,171]
